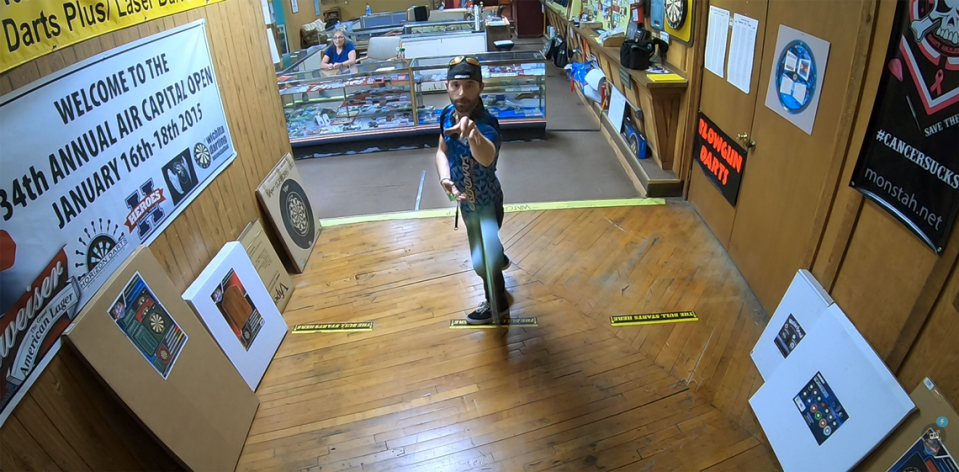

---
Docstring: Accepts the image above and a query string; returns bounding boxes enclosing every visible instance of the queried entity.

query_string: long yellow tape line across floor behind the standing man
[320,198,666,227]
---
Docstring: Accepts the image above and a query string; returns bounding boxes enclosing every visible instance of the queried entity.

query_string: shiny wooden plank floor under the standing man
[237,201,779,472]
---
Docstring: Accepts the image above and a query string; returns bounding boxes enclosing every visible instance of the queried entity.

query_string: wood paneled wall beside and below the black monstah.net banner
[808,2,959,406]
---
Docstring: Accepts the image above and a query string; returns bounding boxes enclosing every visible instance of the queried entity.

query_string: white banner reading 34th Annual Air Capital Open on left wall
[0,20,236,424]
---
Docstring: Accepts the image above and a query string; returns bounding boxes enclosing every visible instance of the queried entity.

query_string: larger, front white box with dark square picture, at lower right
[749,304,915,472]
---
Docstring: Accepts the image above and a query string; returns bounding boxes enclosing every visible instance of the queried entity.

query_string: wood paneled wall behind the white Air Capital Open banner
[0,0,292,470]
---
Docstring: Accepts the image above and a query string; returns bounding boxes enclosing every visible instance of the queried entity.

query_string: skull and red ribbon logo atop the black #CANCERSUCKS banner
[890,0,959,115]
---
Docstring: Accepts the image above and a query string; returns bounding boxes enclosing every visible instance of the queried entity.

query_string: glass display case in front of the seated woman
[279,61,416,144]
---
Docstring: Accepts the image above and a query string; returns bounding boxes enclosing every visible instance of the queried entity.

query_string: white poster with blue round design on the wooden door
[766,25,829,135]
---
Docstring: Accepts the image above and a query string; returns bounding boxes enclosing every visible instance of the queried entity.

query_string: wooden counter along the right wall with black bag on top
[573,27,688,169]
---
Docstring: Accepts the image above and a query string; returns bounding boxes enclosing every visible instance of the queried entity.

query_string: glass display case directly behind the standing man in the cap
[410,51,546,126]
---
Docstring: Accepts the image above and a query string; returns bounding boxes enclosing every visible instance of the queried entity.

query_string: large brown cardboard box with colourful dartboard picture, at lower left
[64,246,259,470]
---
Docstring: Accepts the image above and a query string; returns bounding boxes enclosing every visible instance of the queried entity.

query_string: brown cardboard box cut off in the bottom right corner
[859,378,959,472]
